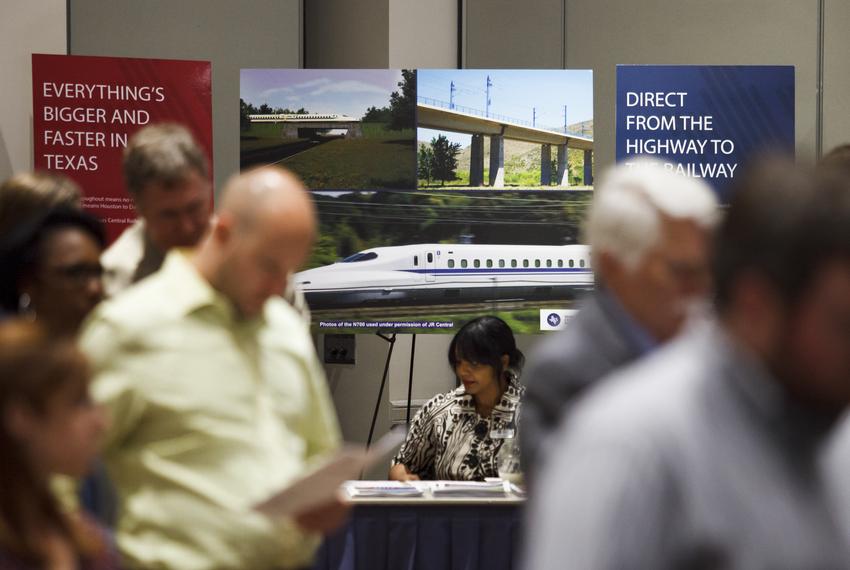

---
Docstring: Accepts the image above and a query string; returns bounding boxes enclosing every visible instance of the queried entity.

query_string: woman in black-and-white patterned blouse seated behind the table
[389,317,525,481]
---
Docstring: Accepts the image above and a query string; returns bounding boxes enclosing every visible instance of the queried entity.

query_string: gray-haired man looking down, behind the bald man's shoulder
[101,123,212,296]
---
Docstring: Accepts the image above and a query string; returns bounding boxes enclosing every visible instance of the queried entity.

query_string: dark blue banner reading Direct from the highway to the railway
[617,65,794,202]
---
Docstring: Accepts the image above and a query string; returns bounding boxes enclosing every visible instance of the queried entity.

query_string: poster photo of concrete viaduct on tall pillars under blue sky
[416,70,593,190]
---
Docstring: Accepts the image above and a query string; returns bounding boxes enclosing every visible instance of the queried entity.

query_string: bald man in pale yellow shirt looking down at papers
[81,168,344,569]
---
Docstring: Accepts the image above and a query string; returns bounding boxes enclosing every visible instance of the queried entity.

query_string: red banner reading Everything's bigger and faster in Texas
[32,54,212,242]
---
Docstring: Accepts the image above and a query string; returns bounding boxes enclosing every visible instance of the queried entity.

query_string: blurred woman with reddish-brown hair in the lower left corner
[0,319,118,570]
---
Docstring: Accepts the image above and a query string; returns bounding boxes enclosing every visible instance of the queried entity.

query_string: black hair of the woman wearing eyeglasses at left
[0,207,106,313]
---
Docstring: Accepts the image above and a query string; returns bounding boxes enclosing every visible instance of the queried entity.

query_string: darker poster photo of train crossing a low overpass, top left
[239,69,416,190]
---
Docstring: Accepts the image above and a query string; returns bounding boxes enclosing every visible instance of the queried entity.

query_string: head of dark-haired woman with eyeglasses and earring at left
[0,208,105,337]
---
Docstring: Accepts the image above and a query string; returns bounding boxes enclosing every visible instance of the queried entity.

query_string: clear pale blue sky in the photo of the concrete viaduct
[416,69,593,147]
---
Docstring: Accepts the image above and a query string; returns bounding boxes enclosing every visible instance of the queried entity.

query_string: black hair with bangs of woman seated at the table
[449,316,525,378]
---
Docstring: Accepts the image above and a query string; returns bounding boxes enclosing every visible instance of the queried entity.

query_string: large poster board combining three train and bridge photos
[240,69,593,333]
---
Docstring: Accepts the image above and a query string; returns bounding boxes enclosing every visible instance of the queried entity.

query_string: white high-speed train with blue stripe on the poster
[295,244,593,310]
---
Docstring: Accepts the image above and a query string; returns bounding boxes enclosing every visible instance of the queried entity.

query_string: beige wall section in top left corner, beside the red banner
[0,0,67,180]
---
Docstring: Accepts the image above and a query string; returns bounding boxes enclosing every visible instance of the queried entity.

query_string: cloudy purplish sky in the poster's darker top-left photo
[239,69,401,119]
